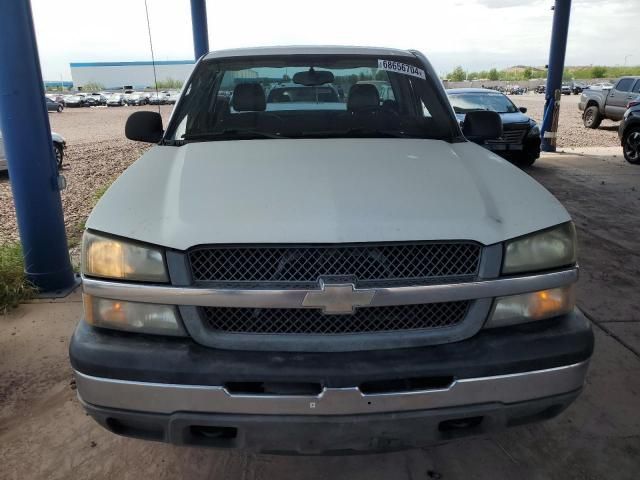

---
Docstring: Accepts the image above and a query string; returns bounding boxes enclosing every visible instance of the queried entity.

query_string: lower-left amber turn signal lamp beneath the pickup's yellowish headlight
[82,294,184,336]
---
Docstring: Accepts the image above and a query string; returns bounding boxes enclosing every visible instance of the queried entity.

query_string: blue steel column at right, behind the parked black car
[540,0,571,152]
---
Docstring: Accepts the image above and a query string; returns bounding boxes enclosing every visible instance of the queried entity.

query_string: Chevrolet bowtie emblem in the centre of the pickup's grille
[302,280,376,315]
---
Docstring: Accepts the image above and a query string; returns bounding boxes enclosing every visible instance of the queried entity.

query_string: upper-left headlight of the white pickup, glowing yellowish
[82,232,169,282]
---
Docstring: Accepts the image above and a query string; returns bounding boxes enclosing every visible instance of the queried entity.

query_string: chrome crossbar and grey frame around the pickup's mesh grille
[82,262,578,352]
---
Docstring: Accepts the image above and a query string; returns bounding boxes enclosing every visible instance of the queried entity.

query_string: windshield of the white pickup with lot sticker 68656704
[165,55,456,144]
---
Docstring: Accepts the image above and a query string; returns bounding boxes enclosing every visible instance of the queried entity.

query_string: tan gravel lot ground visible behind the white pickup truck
[0,94,619,243]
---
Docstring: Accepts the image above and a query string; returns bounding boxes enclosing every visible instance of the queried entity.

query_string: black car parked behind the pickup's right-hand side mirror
[447,88,540,167]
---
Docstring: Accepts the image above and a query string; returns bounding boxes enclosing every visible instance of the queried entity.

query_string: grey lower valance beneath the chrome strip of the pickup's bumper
[84,390,580,455]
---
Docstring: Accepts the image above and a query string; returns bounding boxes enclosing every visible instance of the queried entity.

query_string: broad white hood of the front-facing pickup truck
[87,139,570,250]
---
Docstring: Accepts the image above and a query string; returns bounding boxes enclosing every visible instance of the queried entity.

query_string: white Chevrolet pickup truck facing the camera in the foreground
[70,47,593,454]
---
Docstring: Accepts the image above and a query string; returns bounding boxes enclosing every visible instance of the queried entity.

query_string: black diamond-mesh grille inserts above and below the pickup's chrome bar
[187,242,482,342]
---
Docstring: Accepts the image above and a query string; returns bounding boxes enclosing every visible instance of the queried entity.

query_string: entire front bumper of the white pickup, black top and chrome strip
[70,310,593,453]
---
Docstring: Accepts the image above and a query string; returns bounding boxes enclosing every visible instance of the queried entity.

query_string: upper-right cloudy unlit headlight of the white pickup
[502,222,577,274]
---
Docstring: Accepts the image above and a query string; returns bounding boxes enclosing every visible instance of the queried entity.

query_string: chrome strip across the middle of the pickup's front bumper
[75,360,589,415]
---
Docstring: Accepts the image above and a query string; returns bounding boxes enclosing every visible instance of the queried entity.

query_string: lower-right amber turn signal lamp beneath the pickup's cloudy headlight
[485,284,576,328]
